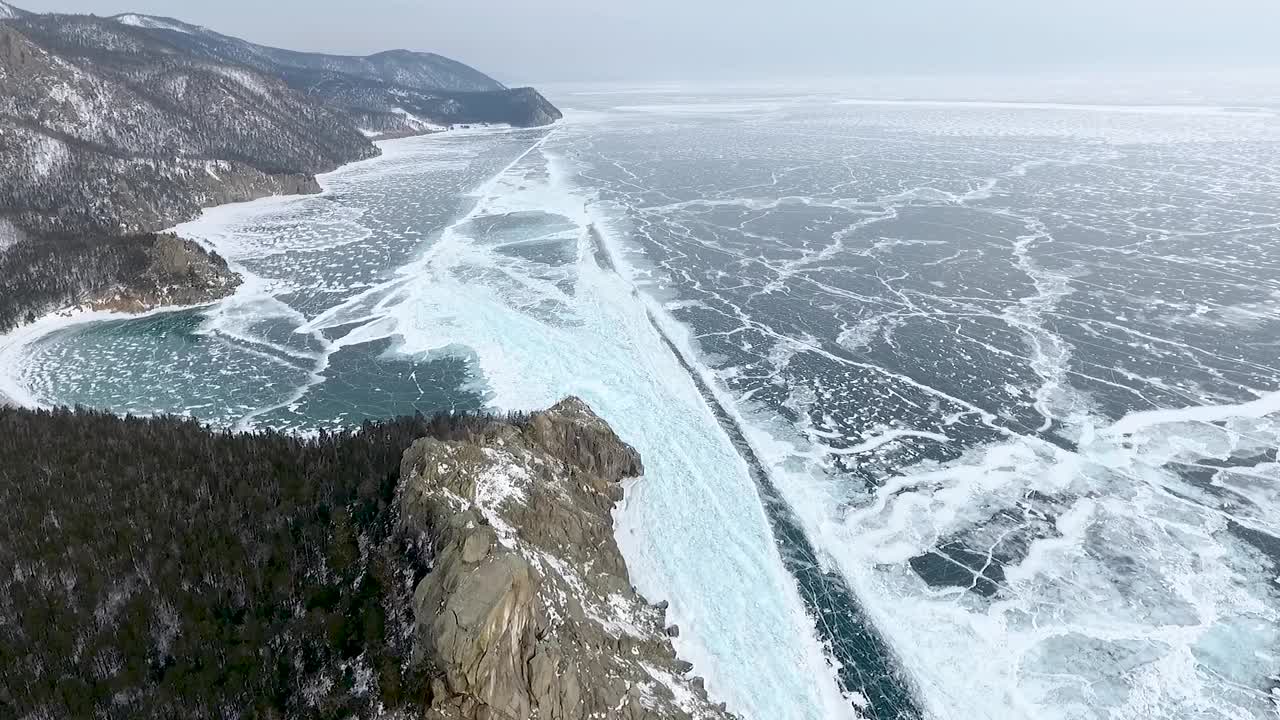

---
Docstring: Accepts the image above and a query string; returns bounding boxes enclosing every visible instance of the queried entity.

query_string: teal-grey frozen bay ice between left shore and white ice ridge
[10,132,532,429]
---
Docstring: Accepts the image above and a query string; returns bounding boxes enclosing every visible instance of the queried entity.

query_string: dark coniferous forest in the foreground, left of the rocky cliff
[0,409,506,719]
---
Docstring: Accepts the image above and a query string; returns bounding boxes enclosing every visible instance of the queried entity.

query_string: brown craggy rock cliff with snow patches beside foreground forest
[401,398,731,720]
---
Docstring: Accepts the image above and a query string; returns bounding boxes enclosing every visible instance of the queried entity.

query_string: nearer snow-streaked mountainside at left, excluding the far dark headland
[0,15,376,233]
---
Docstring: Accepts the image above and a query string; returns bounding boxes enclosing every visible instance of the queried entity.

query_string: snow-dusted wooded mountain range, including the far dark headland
[0,3,561,329]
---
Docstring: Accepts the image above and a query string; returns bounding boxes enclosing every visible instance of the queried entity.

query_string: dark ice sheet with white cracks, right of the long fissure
[537,94,1280,720]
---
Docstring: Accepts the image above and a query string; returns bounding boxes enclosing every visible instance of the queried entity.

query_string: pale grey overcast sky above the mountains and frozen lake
[14,0,1280,83]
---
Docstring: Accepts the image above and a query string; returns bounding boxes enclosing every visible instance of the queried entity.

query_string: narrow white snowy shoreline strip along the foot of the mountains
[0,126,535,409]
